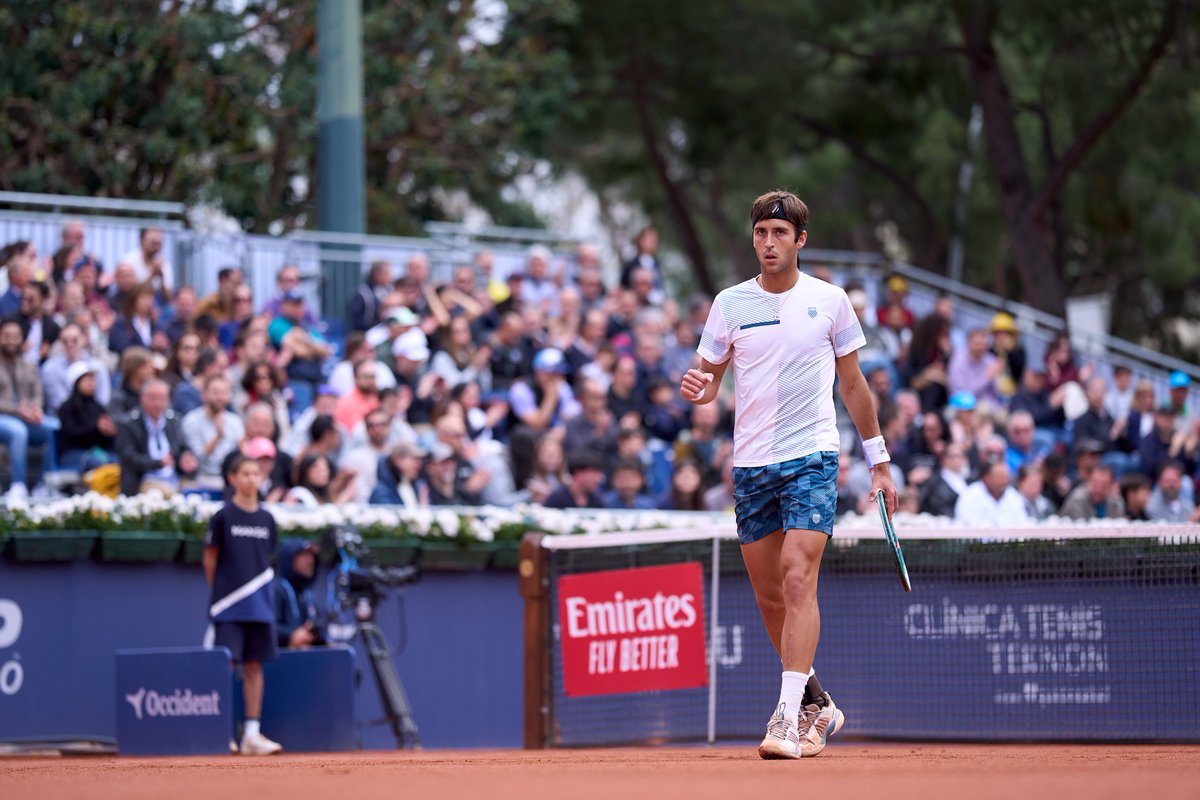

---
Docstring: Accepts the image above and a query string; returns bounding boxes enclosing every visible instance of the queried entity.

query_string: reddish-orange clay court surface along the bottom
[0,744,1200,800]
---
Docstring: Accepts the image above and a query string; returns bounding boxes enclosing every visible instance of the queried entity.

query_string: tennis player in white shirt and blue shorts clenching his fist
[679,191,896,758]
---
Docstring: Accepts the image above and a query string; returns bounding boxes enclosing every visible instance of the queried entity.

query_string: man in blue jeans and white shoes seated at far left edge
[0,318,55,500]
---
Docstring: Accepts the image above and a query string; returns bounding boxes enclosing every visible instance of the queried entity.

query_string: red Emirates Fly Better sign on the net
[558,561,708,697]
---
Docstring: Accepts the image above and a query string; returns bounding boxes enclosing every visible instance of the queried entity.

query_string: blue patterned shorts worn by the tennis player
[733,451,838,545]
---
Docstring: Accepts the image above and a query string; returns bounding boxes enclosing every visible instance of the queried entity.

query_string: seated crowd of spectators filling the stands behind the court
[0,222,1200,527]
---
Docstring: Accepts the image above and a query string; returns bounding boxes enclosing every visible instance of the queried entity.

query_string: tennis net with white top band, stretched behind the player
[521,527,1200,747]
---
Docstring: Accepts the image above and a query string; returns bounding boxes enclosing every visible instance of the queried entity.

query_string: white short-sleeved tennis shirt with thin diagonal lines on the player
[696,272,866,467]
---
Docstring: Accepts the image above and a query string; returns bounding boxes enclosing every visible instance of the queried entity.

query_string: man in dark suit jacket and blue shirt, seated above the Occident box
[116,378,199,494]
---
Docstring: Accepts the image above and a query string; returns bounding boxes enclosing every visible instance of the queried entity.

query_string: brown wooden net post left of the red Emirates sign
[517,534,550,750]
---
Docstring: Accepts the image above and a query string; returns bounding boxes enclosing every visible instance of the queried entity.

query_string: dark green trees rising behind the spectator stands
[0,0,1200,348]
